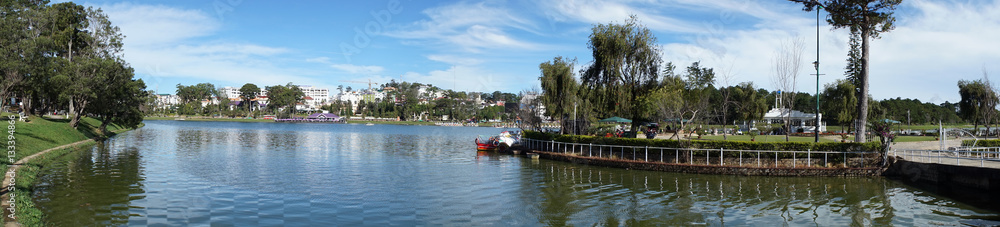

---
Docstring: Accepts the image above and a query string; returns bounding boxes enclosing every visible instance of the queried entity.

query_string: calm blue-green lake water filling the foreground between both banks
[34,121,1000,226]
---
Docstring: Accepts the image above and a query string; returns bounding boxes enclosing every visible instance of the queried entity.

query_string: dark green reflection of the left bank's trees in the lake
[33,138,146,226]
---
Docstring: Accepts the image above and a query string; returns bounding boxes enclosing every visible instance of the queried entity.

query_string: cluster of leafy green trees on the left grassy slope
[0,0,152,132]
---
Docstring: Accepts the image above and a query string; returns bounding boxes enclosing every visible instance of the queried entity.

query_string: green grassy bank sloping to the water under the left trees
[0,114,133,226]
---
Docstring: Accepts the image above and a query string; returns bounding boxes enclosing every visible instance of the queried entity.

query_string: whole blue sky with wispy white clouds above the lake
[64,0,1000,103]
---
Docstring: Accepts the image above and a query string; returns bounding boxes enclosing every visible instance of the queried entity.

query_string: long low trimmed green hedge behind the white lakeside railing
[523,131,884,152]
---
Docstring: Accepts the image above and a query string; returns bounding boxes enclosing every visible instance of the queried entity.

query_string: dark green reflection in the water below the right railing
[522,160,997,226]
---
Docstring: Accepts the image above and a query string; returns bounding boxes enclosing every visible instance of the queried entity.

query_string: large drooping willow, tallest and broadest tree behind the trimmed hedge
[582,15,663,137]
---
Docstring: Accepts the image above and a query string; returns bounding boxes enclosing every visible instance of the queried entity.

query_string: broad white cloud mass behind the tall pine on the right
[640,0,1000,103]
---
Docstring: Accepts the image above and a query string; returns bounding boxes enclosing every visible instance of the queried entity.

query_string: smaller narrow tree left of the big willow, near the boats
[538,56,580,134]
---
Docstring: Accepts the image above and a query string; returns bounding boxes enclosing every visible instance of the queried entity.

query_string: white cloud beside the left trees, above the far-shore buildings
[100,3,317,91]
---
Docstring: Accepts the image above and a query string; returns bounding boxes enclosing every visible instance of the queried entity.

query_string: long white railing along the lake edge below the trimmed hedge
[520,139,882,168]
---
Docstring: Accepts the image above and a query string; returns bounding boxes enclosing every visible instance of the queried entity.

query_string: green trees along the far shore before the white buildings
[166,80,520,121]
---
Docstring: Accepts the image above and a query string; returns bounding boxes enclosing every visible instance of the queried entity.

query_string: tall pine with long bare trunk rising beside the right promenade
[790,0,903,142]
